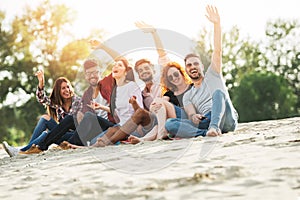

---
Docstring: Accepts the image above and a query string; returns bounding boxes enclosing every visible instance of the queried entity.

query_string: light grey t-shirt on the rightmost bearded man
[183,67,229,115]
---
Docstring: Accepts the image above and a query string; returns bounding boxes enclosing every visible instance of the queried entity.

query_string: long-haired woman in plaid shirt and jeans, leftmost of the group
[3,70,81,157]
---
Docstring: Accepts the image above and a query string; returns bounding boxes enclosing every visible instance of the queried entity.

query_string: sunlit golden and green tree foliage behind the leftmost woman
[0,1,98,145]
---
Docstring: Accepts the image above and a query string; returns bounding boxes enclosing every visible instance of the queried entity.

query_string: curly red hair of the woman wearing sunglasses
[160,62,192,94]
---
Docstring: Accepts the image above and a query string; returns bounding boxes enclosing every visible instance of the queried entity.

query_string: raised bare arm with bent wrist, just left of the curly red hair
[135,22,167,57]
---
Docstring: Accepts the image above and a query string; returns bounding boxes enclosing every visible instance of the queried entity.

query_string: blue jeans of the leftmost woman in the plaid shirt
[20,117,57,151]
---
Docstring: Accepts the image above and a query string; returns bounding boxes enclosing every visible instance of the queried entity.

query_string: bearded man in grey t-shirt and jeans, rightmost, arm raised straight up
[165,6,238,138]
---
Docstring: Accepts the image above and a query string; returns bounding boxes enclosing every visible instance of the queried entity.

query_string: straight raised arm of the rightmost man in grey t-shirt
[206,6,222,73]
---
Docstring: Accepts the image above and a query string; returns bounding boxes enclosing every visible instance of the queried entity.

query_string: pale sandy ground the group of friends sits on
[0,117,300,200]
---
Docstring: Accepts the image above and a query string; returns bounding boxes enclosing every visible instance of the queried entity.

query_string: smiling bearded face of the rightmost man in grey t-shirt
[185,57,204,81]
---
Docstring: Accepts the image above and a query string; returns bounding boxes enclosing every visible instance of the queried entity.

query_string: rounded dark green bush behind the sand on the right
[233,72,296,122]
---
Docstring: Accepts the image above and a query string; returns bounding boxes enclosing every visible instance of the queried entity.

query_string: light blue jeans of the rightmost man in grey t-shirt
[165,90,238,138]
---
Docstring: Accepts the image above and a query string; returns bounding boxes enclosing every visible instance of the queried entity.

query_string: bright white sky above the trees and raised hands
[0,0,300,39]
